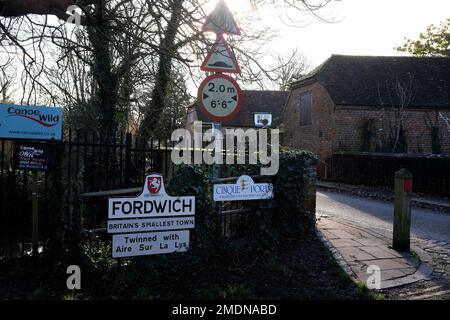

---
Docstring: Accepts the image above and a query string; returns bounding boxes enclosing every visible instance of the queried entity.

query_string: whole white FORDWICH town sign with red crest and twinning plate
[107,174,195,258]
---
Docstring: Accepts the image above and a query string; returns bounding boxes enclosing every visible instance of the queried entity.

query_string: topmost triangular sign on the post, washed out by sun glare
[202,0,241,35]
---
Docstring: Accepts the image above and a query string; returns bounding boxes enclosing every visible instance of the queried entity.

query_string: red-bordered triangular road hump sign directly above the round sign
[200,35,241,73]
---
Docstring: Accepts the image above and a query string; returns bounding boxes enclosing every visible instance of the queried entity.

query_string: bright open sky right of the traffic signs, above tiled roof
[220,0,450,67]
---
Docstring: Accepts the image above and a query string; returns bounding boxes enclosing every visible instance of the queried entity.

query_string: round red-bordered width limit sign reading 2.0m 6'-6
[198,74,243,122]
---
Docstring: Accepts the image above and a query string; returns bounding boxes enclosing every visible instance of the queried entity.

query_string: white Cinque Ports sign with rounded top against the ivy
[213,176,273,202]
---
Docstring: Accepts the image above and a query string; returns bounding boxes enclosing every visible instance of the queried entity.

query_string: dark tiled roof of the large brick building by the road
[292,55,450,108]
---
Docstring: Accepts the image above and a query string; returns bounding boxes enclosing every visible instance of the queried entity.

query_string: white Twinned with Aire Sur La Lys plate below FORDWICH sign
[112,230,189,258]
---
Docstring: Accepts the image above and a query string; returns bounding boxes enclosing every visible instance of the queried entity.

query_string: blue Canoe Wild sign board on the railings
[0,104,63,140]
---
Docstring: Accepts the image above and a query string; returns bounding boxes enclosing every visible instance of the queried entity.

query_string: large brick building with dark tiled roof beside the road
[282,55,450,176]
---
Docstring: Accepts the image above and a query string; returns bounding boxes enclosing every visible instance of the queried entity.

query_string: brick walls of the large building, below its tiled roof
[282,82,450,176]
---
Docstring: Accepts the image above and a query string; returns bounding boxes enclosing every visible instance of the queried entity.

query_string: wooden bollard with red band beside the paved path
[393,169,412,251]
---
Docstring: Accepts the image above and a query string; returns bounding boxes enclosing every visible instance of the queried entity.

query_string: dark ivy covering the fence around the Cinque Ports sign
[164,150,317,253]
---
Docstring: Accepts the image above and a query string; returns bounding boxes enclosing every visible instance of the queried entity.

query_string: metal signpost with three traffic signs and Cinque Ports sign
[197,0,273,212]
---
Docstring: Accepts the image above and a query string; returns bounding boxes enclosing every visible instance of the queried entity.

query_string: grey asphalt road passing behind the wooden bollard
[317,191,450,242]
